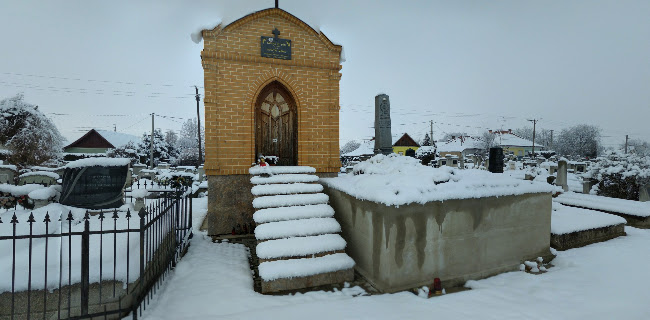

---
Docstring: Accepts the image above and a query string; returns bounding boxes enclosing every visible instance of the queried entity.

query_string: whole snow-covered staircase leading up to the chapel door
[249,167,354,293]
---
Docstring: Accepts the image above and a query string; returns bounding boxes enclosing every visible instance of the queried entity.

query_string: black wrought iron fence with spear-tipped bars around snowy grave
[0,191,192,319]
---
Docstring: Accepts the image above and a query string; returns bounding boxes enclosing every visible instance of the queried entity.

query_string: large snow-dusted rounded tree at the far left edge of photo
[0,94,64,167]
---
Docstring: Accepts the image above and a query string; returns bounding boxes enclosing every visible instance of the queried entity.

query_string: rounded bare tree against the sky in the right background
[554,124,602,158]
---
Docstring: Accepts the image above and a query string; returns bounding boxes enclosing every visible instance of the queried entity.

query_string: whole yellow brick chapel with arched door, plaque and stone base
[201,8,342,235]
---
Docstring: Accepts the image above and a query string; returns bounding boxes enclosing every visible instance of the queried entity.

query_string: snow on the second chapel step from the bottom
[256,234,346,260]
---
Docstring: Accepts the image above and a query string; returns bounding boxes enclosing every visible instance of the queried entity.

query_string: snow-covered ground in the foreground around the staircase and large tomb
[139,198,650,319]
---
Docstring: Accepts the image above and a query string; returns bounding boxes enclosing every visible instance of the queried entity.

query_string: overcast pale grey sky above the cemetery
[0,0,650,150]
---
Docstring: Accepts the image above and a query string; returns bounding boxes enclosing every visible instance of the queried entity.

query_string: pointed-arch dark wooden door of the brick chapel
[255,81,298,166]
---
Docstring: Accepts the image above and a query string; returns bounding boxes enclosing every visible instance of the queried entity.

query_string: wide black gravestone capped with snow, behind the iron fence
[59,158,130,209]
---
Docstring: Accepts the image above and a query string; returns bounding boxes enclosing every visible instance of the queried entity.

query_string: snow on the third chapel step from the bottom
[255,218,341,240]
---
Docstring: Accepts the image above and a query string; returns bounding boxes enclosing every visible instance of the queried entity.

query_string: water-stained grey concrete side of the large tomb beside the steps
[325,187,552,292]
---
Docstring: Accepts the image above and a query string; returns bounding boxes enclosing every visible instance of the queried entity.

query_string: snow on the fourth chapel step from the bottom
[253,204,334,224]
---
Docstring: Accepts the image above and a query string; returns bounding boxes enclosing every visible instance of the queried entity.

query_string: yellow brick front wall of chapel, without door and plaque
[201,9,341,175]
